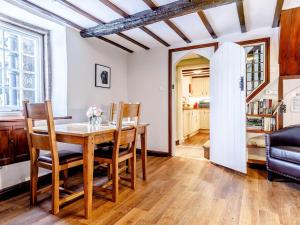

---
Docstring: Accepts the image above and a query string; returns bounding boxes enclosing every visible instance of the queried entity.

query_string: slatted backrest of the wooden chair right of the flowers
[114,102,141,157]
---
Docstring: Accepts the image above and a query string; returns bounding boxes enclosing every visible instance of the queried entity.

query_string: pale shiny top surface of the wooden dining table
[33,123,149,137]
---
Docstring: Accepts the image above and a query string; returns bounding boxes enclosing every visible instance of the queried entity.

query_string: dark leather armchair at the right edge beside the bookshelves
[266,125,300,181]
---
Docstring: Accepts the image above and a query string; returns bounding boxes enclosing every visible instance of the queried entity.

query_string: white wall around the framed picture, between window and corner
[67,29,127,121]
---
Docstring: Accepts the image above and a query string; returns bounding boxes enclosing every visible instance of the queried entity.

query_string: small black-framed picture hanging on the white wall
[95,64,111,88]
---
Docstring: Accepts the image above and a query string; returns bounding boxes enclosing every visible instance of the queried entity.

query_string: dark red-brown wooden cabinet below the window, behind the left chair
[0,120,29,166]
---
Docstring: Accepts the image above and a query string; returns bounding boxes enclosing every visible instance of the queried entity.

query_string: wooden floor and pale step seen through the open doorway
[175,131,209,160]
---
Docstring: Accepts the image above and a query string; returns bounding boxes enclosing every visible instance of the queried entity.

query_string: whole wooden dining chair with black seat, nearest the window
[23,101,84,214]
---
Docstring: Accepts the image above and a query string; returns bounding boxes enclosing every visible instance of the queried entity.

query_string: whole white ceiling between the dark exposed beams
[5,0,299,51]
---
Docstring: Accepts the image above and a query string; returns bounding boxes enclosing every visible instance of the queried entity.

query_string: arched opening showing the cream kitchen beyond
[175,53,210,159]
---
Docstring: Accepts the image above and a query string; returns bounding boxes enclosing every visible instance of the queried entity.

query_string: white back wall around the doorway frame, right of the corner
[128,28,279,152]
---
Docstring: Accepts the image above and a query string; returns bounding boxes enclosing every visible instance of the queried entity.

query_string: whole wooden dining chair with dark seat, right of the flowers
[94,102,140,202]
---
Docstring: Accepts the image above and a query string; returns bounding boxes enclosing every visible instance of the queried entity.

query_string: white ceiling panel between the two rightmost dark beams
[244,0,276,31]
